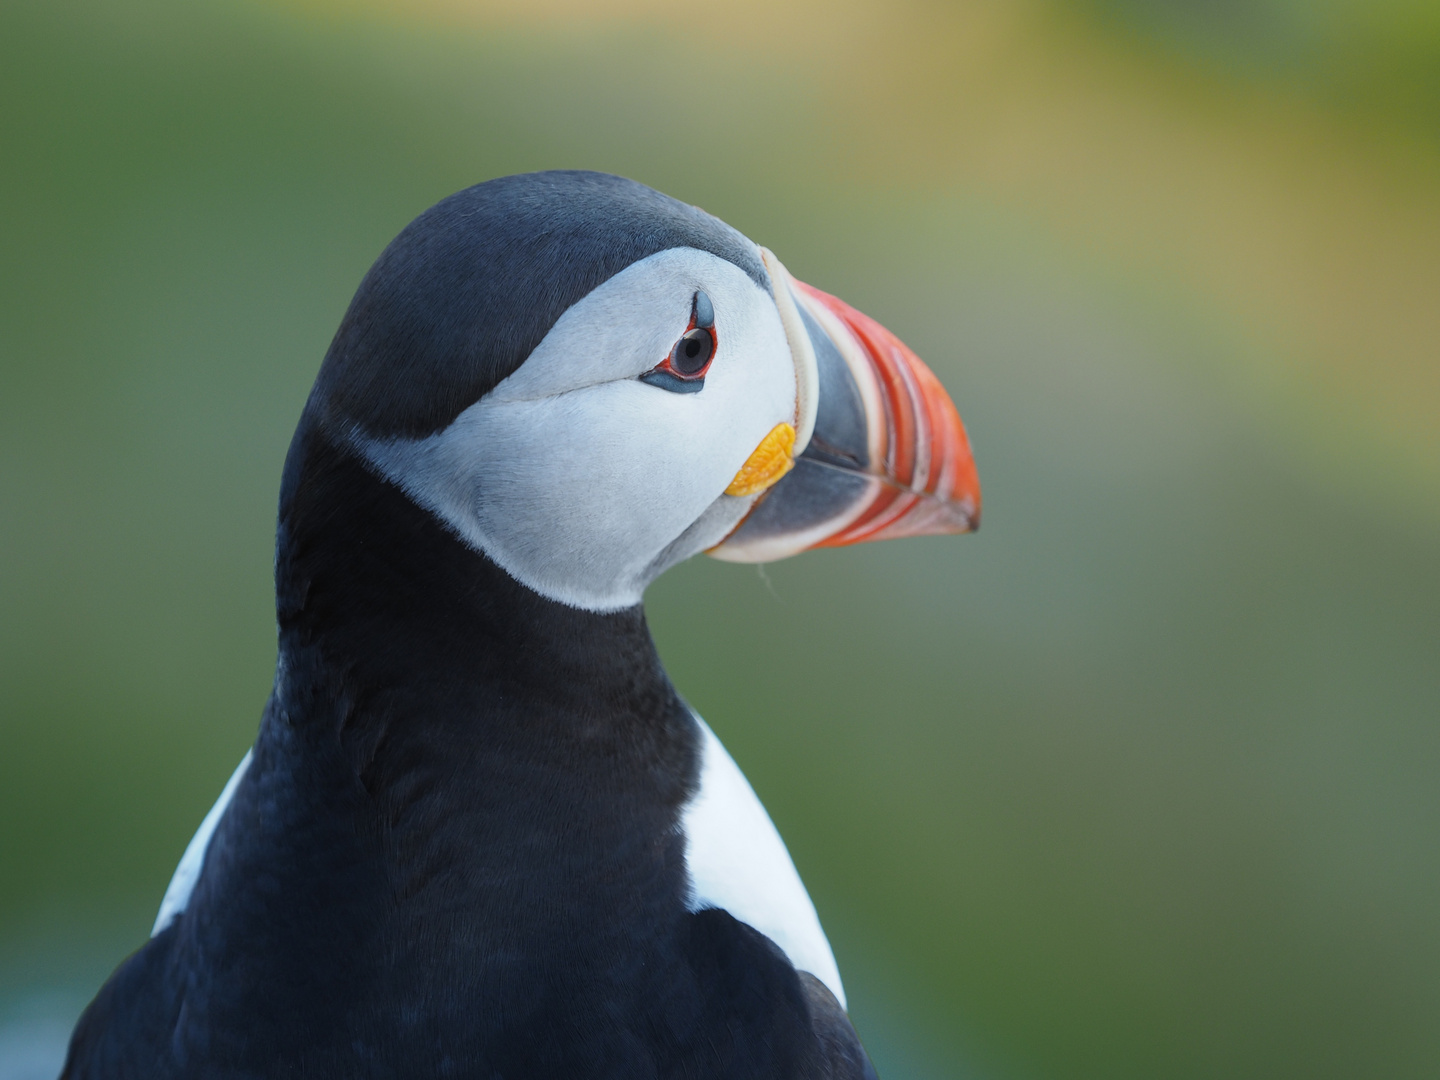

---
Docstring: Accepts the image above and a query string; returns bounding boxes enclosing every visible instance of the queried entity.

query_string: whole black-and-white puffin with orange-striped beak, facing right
[62,171,981,1080]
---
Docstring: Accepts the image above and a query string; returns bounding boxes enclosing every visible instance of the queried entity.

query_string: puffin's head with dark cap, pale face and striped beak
[281,171,981,612]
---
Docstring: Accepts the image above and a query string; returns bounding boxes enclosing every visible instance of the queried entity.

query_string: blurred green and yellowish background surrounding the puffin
[0,0,1440,1080]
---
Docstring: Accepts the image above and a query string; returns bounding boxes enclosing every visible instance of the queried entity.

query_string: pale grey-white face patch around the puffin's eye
[353,248,796,611]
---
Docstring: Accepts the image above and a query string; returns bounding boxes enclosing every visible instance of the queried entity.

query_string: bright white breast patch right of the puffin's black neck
[681,714,845,1008]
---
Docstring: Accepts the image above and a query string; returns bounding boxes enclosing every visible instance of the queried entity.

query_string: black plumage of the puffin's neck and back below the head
[65,174,873,1080]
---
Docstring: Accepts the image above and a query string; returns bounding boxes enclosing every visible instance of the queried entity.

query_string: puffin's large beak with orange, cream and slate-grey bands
[710,249,981,563]
